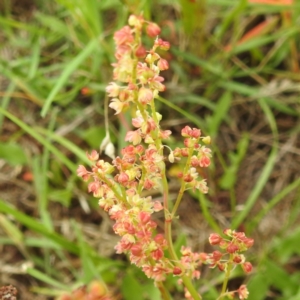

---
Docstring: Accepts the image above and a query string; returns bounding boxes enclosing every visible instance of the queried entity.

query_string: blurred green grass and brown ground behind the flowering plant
[0,0,300,300]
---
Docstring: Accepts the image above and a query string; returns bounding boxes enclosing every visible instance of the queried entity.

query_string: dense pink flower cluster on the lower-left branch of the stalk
[77,145,173,281]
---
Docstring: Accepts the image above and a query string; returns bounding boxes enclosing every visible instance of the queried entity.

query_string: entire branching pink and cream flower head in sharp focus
[77,15,253,299]
